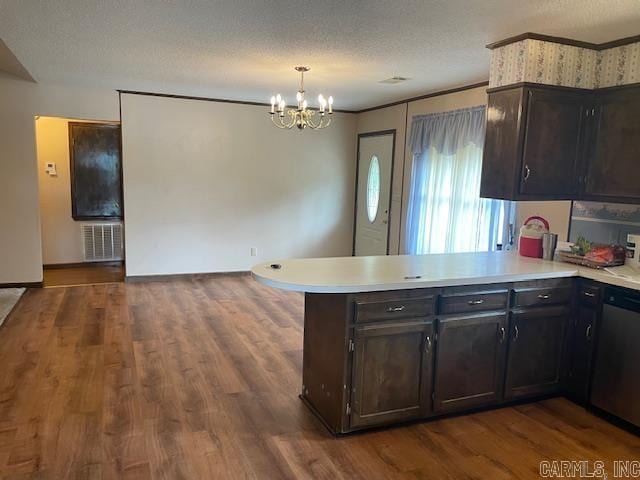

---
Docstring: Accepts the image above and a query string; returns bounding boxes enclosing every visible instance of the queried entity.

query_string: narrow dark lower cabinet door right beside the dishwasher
[567,302,598,403]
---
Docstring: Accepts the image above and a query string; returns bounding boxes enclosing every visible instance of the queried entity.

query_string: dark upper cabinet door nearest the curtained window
[520,89,589,200]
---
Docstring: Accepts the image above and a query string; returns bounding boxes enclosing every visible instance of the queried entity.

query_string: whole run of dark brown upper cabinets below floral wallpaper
[480,84,640,203]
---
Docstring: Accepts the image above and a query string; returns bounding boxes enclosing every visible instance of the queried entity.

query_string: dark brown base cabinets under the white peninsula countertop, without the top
[301,278,602,434]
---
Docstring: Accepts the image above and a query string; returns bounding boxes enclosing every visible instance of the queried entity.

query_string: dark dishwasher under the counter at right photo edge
[591,288,640,427]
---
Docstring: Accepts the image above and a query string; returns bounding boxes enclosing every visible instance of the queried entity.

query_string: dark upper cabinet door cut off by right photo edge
[583,87,640,203]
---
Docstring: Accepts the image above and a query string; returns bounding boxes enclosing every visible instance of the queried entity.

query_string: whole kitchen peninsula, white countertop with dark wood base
[252,252,640,433]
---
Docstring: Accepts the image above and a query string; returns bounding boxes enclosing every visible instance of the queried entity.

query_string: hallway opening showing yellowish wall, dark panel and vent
[35,116,124,287]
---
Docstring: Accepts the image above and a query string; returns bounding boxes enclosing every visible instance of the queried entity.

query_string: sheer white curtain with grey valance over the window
[406,106,512,254]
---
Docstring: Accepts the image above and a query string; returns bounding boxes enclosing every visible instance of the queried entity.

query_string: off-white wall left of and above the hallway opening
[0,74,119,284]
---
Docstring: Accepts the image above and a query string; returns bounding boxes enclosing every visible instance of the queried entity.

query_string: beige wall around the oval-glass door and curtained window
[357,87,571,253]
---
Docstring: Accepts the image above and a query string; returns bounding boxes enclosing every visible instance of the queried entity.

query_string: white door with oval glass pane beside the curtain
[353,130,396,255]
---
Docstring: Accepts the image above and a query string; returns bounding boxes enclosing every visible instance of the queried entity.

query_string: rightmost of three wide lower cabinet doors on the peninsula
[505,307,569,398]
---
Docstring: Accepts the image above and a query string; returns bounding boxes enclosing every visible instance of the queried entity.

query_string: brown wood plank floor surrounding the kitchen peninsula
[0,276,640,480]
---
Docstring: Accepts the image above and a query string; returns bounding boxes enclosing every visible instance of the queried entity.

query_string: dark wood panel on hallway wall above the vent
[69,122,122,220]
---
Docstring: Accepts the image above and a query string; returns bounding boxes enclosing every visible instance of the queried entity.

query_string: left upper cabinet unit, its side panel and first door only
[480,85,592,200]
